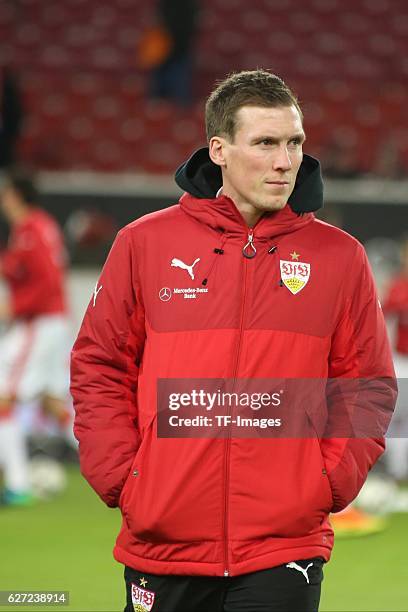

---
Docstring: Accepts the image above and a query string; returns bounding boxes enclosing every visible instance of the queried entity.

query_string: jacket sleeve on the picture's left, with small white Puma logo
[71,229,144,507]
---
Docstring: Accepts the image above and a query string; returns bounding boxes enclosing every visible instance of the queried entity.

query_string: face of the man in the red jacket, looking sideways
[210,106,305,217]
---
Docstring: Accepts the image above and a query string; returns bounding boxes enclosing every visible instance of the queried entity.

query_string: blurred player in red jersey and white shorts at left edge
[0,171,70,505]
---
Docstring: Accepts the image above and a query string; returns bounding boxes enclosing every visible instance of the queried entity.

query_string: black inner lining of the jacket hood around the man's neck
[175,147,323,213]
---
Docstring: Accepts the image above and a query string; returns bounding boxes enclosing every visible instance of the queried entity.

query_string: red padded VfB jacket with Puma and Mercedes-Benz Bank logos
[72,151,395,576]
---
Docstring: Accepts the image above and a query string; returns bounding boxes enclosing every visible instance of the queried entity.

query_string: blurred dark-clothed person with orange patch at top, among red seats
[139,0,199,106]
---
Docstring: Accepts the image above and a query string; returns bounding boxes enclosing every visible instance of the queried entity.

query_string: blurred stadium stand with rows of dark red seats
[0,0,408,173]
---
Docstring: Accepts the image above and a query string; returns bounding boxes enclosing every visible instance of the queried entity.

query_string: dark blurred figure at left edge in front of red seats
[0,66,23,169]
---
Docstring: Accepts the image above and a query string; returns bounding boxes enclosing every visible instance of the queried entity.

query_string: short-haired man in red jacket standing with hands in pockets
[72,70,395,612]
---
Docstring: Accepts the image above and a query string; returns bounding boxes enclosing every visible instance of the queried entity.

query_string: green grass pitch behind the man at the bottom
[0,469,408,612]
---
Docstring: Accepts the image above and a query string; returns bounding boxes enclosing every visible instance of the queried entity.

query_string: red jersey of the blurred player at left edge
[1,208,66,318]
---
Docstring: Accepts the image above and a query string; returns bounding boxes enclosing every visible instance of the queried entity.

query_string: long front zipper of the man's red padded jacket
[223,228,256,577]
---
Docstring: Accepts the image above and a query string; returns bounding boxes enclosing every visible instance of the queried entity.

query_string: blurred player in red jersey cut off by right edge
[383,236,408,481]
